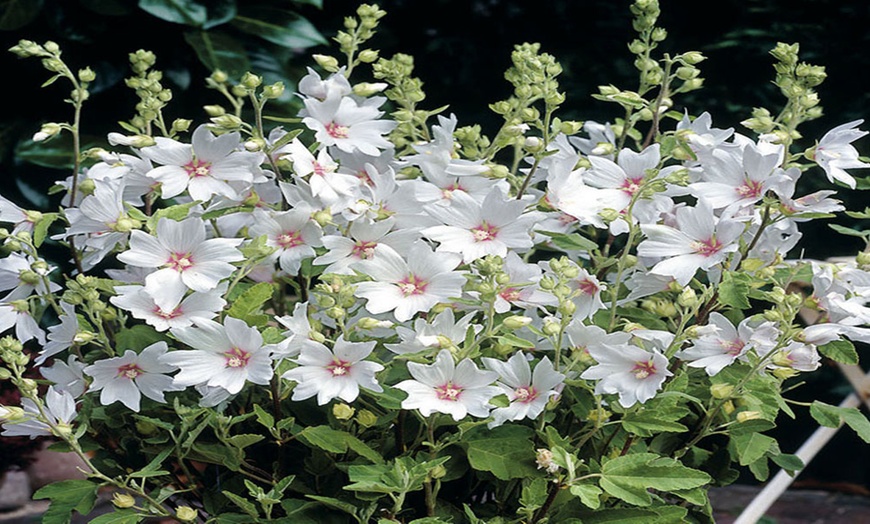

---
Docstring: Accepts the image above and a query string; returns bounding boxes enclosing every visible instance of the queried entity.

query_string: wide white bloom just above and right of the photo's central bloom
[421,187,540,263]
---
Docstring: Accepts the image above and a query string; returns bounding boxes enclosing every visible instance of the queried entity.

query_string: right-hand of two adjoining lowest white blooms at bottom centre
[483,351,565,428]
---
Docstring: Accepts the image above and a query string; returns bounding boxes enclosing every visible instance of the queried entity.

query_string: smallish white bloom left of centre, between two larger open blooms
[248,207,323,276]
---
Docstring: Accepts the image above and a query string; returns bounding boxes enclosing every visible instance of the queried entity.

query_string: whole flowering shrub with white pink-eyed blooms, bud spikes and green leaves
[0,0,870,524]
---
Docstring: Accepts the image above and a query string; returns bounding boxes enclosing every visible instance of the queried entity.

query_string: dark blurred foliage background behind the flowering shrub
[0,0,870,486]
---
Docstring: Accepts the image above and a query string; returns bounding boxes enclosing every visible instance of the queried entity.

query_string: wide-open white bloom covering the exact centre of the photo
[353,241,465,322]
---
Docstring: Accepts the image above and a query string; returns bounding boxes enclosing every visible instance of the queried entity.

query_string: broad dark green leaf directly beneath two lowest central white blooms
[463,426,540,480]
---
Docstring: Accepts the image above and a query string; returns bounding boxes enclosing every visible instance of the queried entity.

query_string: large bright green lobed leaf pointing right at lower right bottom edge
[599,453,712,506]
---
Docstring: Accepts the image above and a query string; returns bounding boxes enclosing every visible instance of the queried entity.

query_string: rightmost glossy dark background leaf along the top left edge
[232,7,327,49]
